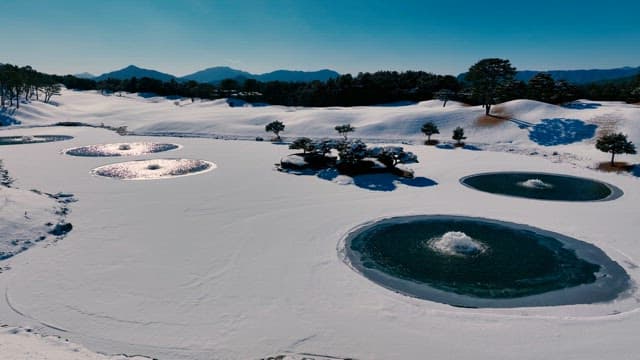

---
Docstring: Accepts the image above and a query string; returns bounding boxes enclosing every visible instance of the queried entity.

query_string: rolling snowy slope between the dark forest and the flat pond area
[8,91,640,168]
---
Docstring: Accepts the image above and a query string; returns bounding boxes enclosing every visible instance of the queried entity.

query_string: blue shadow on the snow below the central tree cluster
[284,169,438,191]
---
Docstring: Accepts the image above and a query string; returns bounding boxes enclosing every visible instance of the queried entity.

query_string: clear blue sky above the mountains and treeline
[0,0,640,76]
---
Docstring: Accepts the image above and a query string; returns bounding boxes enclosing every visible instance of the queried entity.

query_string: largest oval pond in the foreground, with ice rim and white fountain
[341,215,630,308]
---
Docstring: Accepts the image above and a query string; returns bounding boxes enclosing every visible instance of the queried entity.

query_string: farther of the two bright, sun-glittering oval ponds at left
[63,142,180,157]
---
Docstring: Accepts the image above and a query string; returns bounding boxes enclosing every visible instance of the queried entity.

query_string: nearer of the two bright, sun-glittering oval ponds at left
[91,159,216,180]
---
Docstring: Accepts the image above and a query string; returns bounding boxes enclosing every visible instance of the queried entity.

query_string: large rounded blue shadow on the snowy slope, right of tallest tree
[529,118,598,146]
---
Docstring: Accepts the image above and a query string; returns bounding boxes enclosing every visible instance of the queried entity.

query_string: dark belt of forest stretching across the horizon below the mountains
[0,64,640,107]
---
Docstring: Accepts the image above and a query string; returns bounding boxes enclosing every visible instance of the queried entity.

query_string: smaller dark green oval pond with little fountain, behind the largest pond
[460,172,622,201]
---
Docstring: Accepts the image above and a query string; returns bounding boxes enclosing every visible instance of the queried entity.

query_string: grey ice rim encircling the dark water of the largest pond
[336,214,638,310]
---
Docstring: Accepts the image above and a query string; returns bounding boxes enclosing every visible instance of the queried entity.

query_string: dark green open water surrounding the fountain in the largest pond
[350,219,600,298]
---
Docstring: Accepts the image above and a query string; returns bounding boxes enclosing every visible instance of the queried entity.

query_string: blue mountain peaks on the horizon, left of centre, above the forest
[90,65,340,83]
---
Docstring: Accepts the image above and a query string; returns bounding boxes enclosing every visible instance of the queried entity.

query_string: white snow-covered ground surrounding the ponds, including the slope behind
[0,91,640,359]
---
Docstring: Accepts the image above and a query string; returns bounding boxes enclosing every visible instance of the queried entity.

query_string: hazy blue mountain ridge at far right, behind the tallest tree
[458,66,640,84]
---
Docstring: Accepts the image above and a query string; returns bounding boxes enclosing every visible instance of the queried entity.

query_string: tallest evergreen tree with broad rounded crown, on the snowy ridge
[465,58,516,115]
